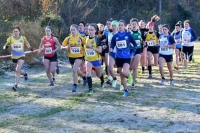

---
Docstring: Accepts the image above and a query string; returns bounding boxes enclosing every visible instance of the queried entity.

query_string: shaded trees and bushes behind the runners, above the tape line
[0,0,200,56]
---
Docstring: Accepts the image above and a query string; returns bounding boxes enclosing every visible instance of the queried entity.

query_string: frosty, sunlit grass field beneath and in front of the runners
[0,43,200,133]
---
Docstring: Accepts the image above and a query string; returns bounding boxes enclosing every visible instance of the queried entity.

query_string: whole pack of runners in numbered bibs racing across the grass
[4,15,197,96]
